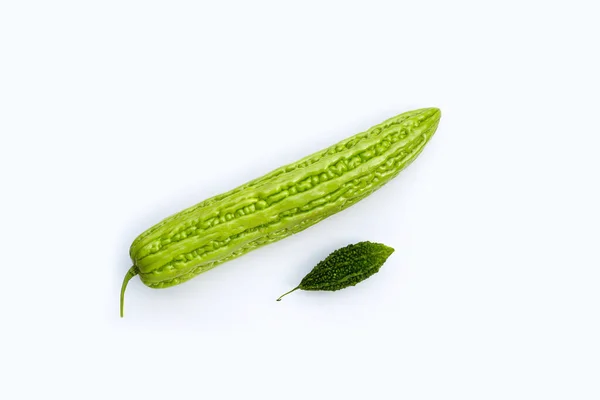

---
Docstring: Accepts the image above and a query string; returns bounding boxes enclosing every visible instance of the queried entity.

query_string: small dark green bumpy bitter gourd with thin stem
[277,242,394,301]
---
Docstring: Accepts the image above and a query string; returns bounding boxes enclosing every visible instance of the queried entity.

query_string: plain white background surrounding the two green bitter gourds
[0,0,600,400]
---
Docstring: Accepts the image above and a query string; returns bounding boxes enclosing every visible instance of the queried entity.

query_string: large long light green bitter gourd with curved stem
[121,108,441,313]
